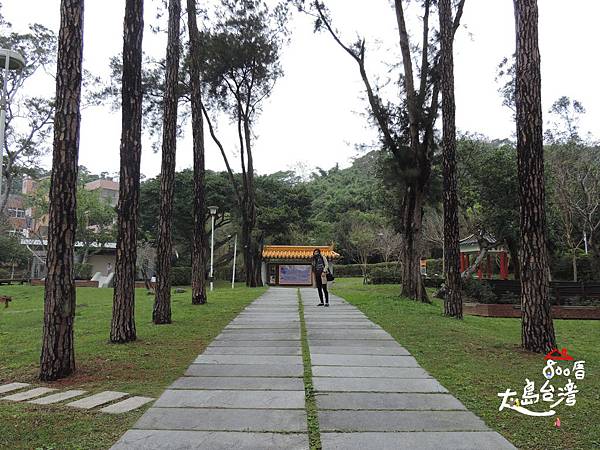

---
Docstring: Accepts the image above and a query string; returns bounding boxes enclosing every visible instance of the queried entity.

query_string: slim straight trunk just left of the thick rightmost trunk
[438,0,462,319]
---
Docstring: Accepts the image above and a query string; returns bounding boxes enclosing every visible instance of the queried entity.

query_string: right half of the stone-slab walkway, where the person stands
[302,289,514,450]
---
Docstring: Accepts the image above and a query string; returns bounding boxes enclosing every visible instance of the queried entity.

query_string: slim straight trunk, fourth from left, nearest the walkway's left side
[187,0,207,305]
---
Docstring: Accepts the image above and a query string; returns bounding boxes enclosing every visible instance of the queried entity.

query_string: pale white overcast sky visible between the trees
[1,0,600,176]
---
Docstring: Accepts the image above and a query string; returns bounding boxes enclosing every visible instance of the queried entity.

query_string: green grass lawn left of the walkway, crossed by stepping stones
[0,283,264,450]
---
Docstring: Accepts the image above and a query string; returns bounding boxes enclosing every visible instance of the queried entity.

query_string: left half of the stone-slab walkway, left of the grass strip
[113,288,308,449]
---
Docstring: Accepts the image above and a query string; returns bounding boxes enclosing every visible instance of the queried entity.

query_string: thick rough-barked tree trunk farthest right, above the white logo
[514,0,556,352]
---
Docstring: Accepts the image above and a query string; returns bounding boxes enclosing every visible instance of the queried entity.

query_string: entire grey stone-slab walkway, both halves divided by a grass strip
[113,288,514,450]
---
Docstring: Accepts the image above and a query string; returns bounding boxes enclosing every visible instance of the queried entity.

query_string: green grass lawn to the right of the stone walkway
[333,279,600,450]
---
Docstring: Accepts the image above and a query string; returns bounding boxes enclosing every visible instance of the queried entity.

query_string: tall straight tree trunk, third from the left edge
[152,0,181,324]
